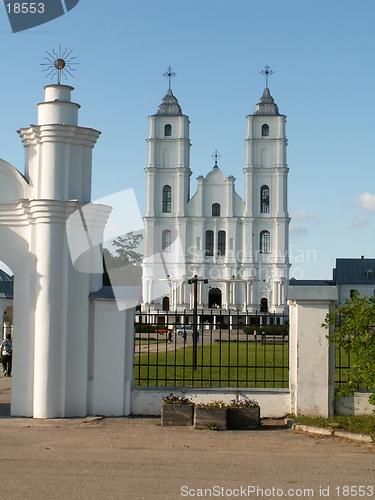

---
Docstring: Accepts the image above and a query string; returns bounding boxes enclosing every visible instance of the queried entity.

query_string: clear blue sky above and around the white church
[0,0,375,279]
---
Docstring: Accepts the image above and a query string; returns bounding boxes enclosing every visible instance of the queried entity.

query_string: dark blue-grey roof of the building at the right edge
[333,259,375,285]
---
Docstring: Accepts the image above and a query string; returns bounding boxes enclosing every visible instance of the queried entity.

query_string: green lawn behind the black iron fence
[134,342,289,388]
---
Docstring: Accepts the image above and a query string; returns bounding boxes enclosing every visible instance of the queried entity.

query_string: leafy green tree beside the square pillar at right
[322,292,375,404]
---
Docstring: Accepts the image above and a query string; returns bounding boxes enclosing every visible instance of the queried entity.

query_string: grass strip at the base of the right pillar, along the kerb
[293,415,375,438]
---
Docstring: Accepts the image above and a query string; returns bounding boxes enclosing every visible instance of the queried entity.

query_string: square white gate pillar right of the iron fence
[288,286,337,417]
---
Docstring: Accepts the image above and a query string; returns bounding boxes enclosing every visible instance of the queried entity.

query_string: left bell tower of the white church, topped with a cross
[143,68,191,304]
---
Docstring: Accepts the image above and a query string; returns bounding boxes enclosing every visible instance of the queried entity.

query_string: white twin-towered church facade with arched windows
[142,85,290,314]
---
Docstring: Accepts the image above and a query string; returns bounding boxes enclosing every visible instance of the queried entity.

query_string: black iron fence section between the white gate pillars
[134,310,289,388]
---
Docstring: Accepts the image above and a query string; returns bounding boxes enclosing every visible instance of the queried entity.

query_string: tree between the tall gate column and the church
[103,231,143,285]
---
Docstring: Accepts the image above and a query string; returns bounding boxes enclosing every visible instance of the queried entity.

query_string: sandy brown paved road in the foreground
[0,377,375,500]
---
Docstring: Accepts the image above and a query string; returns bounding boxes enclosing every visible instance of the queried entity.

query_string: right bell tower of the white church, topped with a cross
[244,75,290,312]
